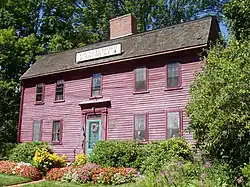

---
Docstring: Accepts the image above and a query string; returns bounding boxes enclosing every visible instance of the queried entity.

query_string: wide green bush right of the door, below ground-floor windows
[89,138,192,172]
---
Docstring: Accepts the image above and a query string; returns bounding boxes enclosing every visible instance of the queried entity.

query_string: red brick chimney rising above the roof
[110,14,137,39]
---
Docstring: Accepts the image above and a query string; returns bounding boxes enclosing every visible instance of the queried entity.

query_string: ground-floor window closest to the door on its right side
[134,114,148,141]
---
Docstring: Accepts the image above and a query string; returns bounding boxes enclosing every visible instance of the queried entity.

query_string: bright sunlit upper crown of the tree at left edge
[0,29,42,83]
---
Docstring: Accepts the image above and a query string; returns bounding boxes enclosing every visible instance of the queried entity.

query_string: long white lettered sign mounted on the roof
[76,44,122,62]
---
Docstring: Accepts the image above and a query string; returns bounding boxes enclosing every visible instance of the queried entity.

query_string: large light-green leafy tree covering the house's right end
[187,39,250,167]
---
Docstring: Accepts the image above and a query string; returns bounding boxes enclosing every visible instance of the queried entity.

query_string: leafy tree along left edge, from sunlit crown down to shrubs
[0,29,42,145]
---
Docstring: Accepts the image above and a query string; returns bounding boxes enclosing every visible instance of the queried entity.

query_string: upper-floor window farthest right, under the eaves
[167,63,181,88]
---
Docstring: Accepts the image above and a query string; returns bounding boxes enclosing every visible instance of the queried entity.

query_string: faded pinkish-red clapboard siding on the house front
[21,50,203,160]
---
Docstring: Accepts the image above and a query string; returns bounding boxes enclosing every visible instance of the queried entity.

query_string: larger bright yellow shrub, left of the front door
[33,148,66,174]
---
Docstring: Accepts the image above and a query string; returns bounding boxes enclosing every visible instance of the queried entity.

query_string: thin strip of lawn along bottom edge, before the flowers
[24,181,137,187]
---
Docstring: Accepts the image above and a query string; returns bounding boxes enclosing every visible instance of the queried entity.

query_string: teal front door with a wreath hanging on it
[86,119,102,155]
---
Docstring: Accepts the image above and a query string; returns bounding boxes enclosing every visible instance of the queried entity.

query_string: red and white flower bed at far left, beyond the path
[0,161,41,180]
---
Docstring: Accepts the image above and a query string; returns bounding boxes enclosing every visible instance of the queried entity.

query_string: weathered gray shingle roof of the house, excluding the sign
[20,17,217,80]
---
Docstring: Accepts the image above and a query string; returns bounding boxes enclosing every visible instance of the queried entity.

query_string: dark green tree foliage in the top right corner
[224,0,250,40]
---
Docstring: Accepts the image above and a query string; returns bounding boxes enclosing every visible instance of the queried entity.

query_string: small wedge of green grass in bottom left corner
[0,174,31,186]
